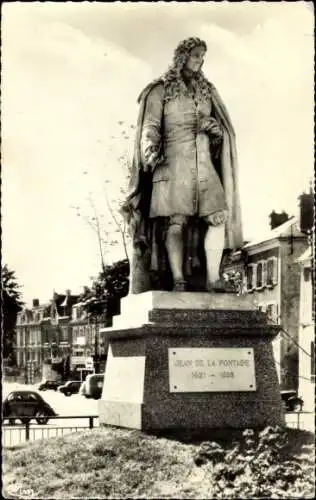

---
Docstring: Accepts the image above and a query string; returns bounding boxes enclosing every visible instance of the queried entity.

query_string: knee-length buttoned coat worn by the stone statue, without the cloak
[141,84,227,218]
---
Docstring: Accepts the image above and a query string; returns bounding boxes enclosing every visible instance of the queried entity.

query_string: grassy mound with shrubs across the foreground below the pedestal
[3,427,314,499]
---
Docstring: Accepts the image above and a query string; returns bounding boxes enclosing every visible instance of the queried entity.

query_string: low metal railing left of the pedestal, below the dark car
[1,415,99,447]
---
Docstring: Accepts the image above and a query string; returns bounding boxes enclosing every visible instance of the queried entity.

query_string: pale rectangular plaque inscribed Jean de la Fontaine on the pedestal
[168,347,256,392]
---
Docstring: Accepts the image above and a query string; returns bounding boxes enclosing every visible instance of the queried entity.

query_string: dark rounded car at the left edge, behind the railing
[2,391,57,425]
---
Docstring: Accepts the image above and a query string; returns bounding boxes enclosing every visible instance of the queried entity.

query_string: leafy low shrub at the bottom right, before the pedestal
[194,426,313,498]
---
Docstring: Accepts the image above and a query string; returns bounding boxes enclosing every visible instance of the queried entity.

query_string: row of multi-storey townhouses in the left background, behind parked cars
[16,290,108,379]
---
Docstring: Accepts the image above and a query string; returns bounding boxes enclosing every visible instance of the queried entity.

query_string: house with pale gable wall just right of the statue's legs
[224,217,308,389]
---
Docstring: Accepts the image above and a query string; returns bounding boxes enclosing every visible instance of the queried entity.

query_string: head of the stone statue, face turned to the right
[173,37,207,73]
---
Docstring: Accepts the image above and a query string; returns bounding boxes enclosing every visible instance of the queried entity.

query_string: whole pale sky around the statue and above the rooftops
[1,1,314,303]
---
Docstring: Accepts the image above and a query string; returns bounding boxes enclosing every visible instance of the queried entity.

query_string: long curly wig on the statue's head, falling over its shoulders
[163,37,212,102]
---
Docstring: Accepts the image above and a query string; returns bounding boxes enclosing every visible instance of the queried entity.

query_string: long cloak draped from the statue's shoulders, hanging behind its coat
[122,78,243,293]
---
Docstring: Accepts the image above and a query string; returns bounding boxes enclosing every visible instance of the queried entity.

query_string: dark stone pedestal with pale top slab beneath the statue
[99,292,284,431]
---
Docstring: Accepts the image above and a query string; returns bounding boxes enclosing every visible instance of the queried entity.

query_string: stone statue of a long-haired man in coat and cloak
[123,38,243,293]
